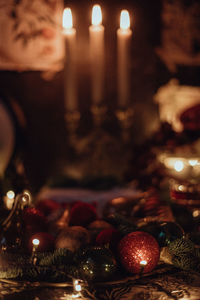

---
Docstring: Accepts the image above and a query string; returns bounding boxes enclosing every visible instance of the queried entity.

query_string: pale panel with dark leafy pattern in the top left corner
[0,0,64,71]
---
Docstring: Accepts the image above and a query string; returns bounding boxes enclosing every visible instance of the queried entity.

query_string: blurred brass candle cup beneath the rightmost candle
[115,107,134,142]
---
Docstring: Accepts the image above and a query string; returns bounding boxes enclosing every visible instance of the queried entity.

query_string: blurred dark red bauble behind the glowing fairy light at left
[28,232,55,252]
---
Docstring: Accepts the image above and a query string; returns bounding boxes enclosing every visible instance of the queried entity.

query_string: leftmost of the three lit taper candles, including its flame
[63,8,78,111]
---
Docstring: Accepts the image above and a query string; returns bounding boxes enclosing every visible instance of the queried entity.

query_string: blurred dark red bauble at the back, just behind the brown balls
[69,202,97,227]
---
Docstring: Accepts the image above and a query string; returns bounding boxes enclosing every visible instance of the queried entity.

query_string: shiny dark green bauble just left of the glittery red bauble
[78,247,117,281]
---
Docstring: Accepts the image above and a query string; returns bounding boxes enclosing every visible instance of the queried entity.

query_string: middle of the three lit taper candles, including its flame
[89,5,104,105]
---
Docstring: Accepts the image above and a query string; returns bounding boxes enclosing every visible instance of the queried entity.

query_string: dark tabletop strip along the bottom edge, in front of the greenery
[0,267,200,300]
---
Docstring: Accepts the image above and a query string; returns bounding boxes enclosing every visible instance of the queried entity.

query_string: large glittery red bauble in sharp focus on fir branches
[118,231,160,273]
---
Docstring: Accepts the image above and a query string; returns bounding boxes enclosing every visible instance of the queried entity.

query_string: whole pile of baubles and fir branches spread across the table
[0,192,200,282]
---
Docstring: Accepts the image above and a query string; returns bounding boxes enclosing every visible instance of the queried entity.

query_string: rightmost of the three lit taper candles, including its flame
[117,10,132,107]
